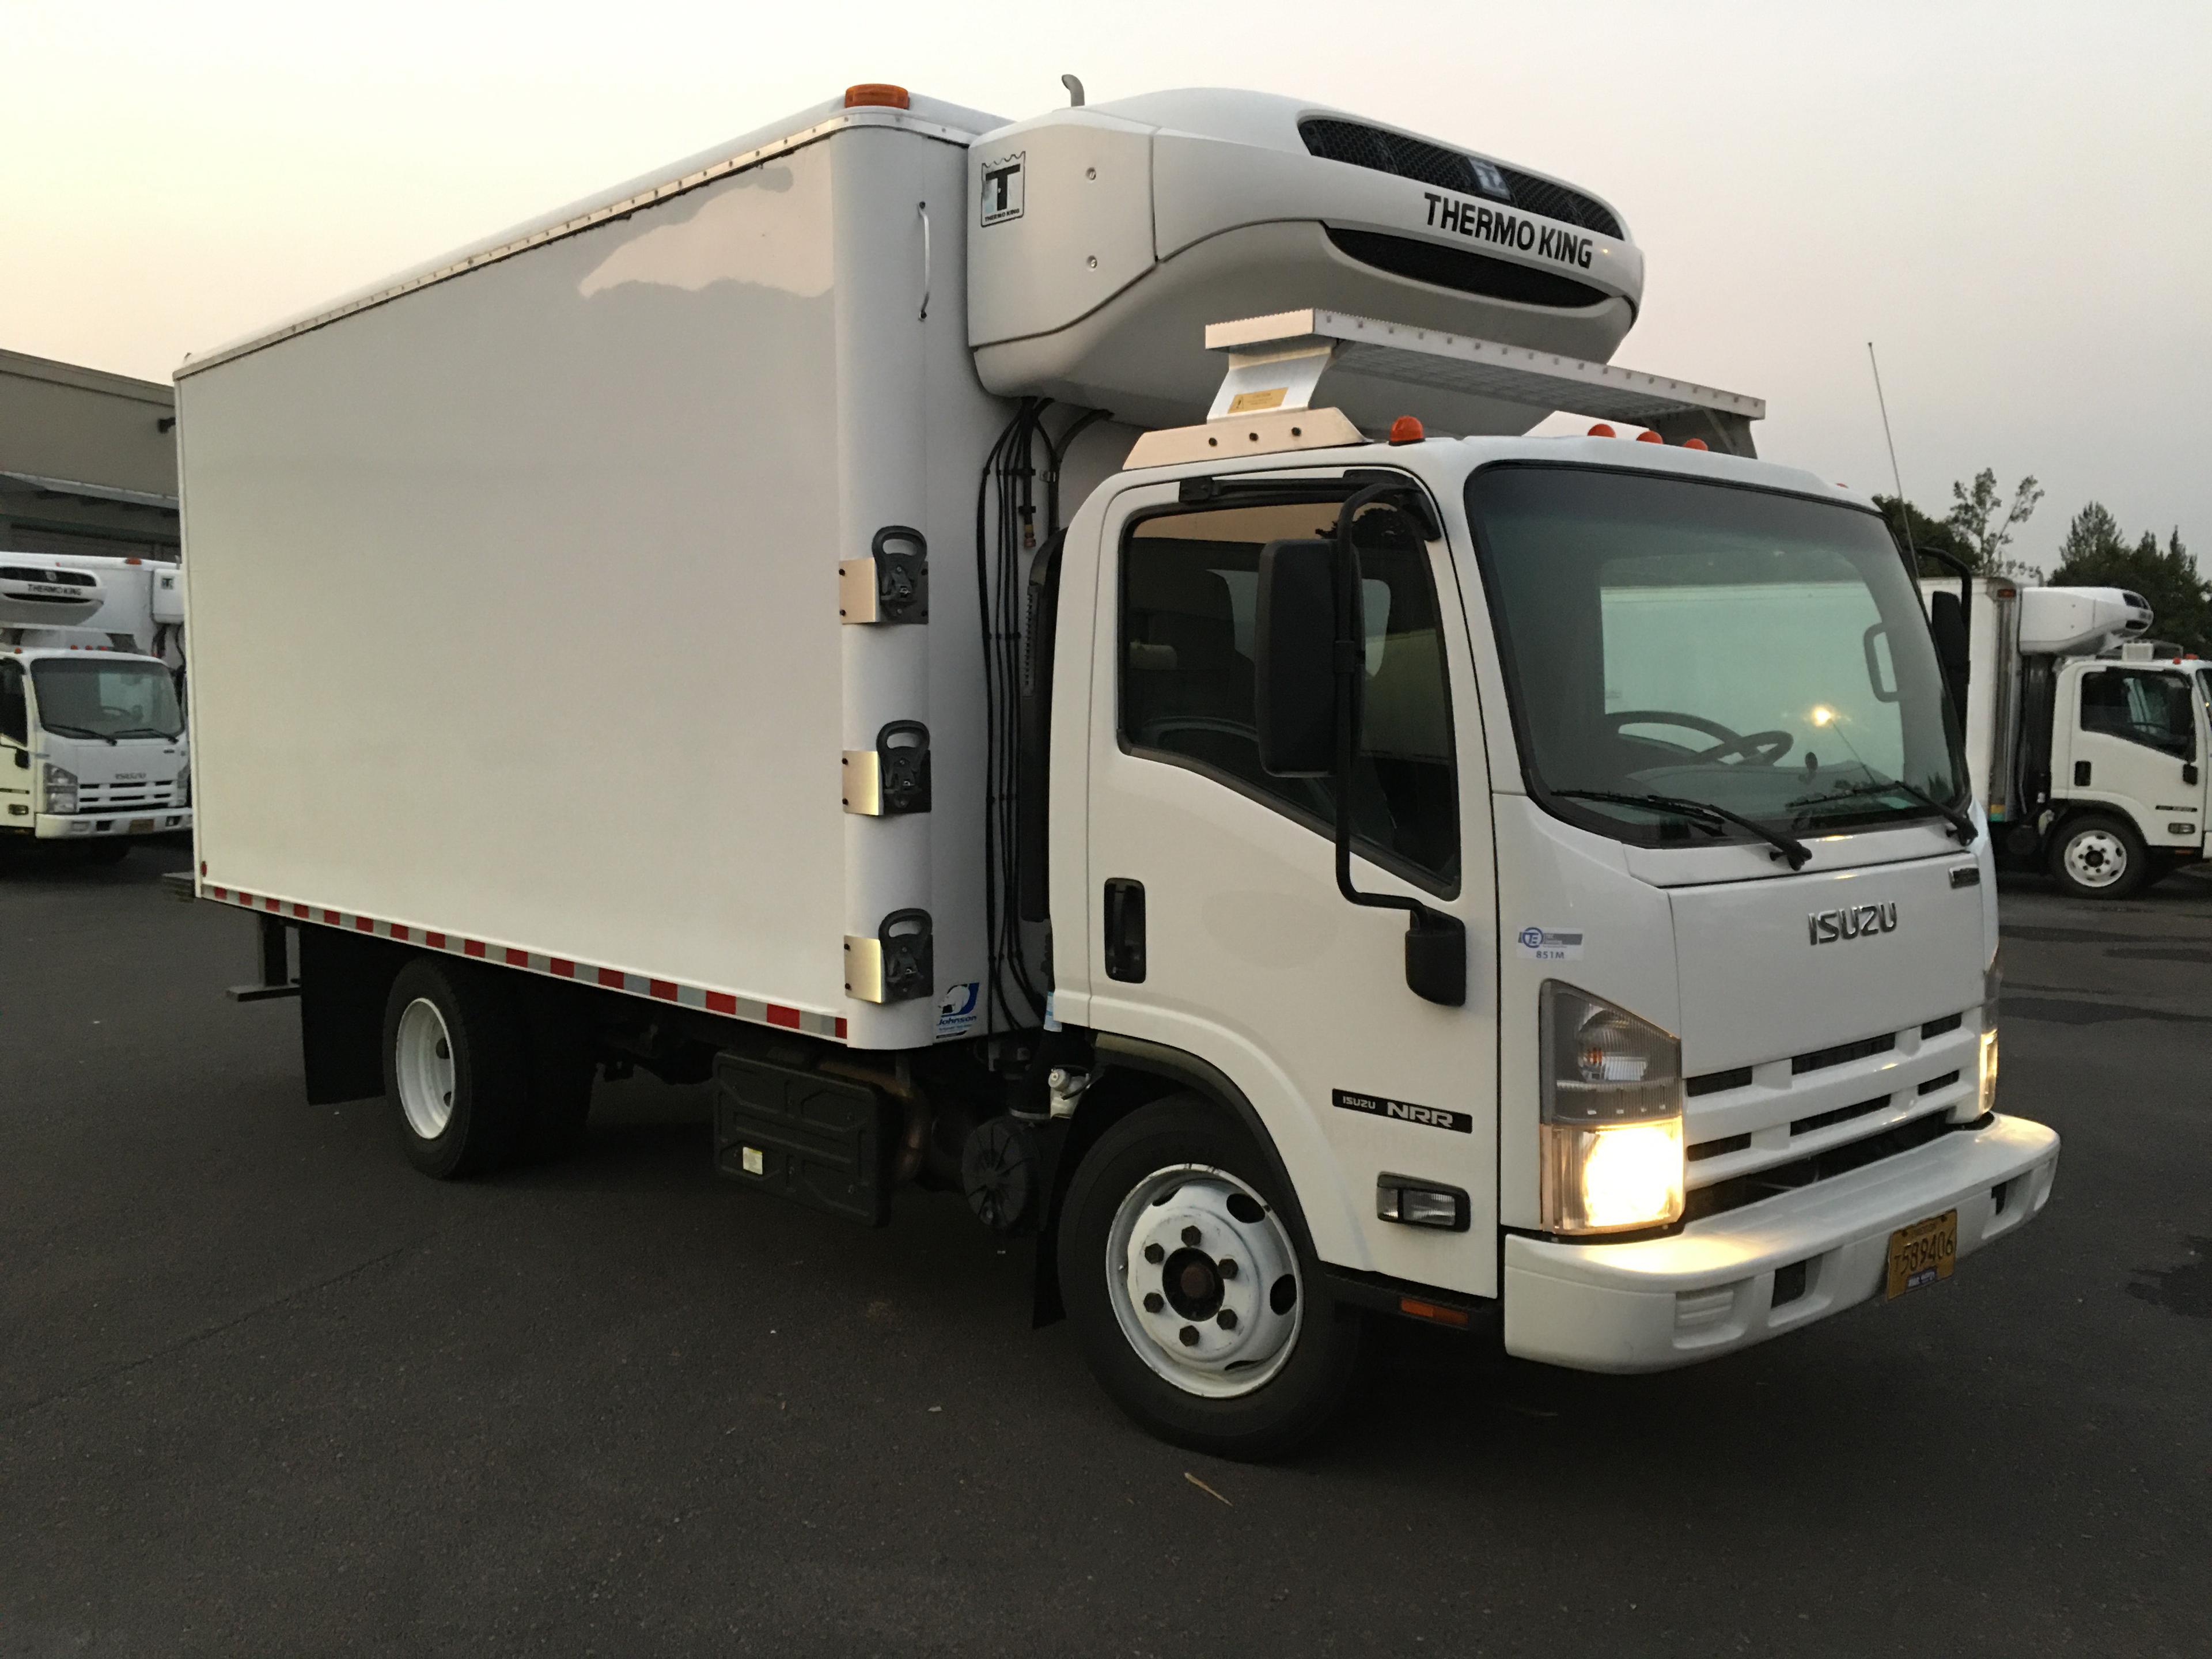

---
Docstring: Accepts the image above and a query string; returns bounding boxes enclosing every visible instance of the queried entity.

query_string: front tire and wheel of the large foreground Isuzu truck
[1055,1095,1361,1460]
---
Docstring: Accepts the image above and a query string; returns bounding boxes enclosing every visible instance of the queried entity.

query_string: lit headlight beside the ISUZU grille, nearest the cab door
[1540,980,1681,1232]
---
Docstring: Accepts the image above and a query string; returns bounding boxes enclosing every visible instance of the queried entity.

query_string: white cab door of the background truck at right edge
[2055,664,2203,847]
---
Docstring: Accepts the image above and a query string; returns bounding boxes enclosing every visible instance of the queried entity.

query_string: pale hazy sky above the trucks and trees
[0,0,2212,571]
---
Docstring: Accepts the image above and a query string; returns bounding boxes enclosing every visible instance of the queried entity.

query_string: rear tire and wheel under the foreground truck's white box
[385,958,529,1181]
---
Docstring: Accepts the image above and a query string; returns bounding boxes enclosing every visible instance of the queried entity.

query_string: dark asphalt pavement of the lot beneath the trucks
[0,850,2212,1659]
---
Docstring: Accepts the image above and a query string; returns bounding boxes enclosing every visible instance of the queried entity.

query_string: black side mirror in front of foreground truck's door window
[1252,540,1336,779]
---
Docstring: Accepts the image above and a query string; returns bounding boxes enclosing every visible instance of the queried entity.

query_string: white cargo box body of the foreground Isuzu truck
[179,100,1009,1048]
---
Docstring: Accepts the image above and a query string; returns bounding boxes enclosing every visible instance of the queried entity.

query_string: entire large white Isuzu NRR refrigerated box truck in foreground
[179,86,2057,1456]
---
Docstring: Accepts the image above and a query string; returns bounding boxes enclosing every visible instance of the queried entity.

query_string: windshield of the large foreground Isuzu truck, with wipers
[1467,464,1964,840]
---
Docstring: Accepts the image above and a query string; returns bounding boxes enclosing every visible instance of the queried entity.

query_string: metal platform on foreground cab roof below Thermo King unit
[1128,310,1767,467]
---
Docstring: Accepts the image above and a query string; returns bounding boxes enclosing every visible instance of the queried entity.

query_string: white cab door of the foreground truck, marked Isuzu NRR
[1055,478,1498,1294]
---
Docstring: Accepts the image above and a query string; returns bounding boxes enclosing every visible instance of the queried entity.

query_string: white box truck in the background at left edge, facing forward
[0,551,192,863]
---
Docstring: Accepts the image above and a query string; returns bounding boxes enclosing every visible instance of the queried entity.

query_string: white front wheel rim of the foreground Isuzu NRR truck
[1104,1164,1305,1400]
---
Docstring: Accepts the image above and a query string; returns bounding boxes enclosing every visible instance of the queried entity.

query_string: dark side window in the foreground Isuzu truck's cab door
[1119,502,1460,896]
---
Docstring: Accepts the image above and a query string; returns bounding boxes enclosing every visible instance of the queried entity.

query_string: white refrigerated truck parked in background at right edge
[1922,577,2212,898]
